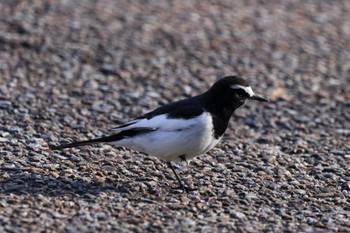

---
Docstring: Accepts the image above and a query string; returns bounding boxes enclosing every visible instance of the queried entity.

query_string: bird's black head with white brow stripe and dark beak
[208,76,268,108]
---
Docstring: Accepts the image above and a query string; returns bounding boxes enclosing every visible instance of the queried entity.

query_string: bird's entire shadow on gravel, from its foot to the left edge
[0,160,191,201]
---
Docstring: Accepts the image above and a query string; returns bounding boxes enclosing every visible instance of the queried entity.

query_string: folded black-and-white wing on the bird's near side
[111,106,204,133]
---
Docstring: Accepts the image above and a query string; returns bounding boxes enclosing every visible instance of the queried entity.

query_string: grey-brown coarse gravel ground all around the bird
[0,0,350,232]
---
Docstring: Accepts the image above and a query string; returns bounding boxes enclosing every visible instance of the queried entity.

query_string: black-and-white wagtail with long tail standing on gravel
[49,75,268,192]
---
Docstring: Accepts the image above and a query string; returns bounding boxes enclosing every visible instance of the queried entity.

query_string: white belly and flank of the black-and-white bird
[112,113,221,161]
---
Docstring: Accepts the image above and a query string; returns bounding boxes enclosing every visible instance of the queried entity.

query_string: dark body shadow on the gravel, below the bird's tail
[0,169,133,199]
